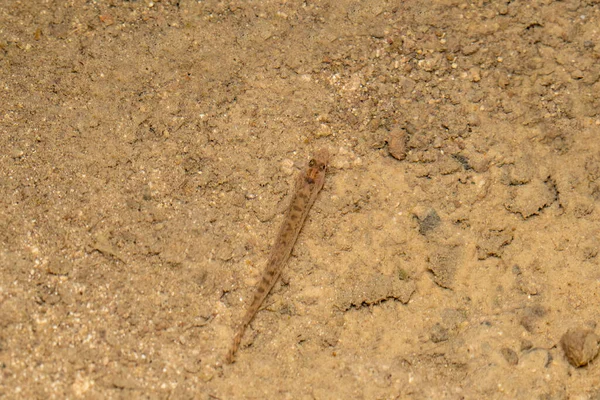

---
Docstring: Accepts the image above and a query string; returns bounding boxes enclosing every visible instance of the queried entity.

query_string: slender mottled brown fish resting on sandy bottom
[225,149,329,364]
